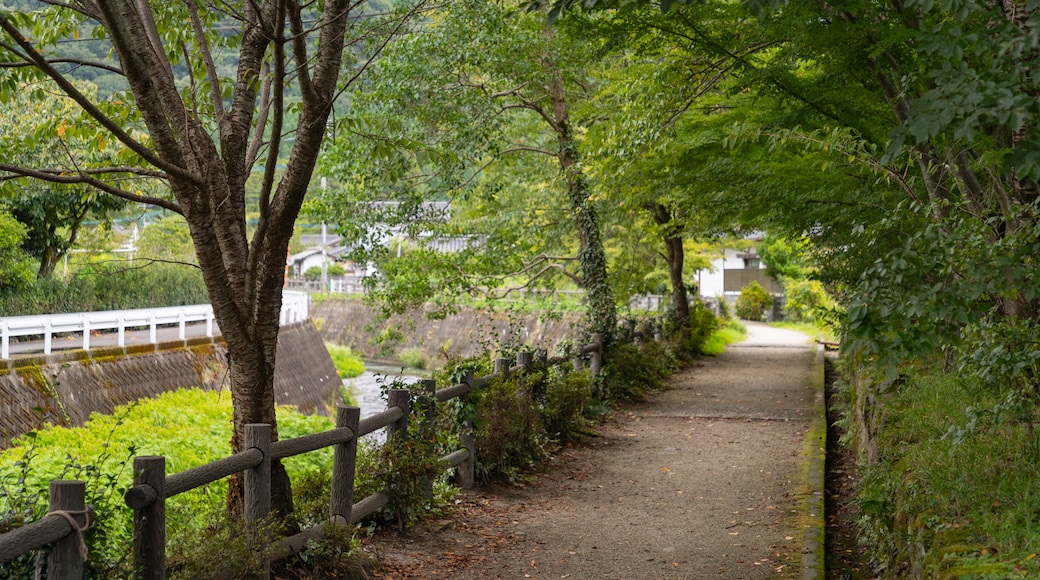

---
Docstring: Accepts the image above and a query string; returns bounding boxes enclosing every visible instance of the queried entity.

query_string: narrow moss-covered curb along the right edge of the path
[802,344,827,580]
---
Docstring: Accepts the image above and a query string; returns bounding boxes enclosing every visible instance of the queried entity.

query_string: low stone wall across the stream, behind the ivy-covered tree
[310,298,582,367]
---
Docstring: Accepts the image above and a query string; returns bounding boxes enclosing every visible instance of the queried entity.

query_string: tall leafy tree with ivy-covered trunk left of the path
[320,0,617,336]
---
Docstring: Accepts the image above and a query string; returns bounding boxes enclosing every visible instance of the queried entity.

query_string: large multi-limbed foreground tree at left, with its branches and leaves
[0,0,422,513]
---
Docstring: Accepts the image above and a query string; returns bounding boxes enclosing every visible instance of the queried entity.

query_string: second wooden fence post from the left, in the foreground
[133,455,166,580]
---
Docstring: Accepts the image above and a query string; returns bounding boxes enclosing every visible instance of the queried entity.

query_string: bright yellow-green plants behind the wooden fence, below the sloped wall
[0,390,332,578]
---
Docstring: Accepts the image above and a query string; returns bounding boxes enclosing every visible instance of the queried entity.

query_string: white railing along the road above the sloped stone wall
[0,290,310,360]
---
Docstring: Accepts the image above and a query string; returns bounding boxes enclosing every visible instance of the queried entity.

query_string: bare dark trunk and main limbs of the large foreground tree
[87,0,350,531]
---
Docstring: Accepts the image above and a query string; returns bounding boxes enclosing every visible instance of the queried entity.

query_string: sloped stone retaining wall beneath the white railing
[0,321,341,449]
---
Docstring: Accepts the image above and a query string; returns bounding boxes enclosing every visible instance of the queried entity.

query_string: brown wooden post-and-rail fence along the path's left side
[0,335,603,580]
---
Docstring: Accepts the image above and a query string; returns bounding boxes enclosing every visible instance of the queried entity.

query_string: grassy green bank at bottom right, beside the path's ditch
[843,367,1040,578]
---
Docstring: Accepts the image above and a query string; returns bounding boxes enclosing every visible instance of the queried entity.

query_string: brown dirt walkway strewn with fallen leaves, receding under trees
[366,324,814,579]
